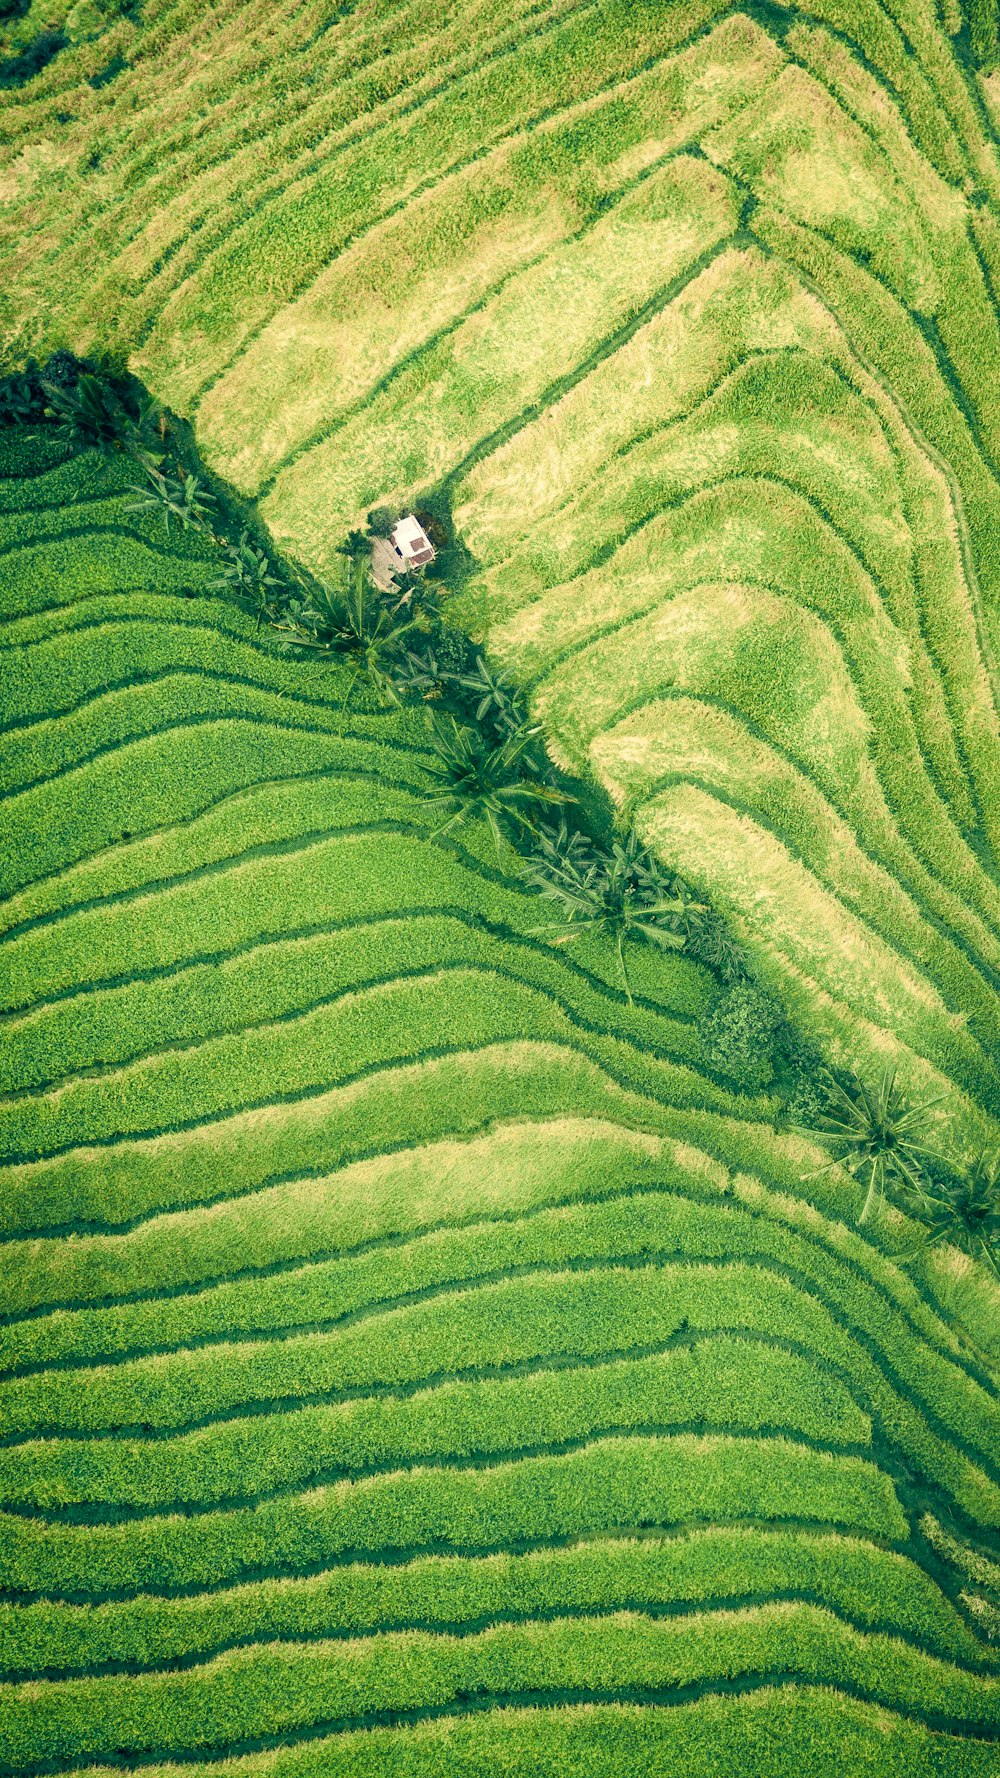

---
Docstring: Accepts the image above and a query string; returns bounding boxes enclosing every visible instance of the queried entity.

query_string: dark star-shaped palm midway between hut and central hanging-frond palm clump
[418,717,568,855]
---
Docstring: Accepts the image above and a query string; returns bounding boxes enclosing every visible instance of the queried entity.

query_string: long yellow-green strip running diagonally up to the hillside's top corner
[198,20,774,489]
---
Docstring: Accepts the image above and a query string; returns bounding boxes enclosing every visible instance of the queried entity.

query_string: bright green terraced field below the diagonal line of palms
[0,445,1000,1773]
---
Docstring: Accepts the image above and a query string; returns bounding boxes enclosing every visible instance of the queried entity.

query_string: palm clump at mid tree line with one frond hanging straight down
[523,820,706,1001]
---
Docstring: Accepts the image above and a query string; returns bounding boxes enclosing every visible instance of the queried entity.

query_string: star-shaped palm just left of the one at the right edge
[799,1067,945,1223]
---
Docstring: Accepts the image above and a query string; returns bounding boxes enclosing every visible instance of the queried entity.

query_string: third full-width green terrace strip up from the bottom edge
[0,1527,996,1671]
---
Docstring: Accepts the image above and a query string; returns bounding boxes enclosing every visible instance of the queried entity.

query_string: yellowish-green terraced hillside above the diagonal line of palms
[0,0,1000,1140]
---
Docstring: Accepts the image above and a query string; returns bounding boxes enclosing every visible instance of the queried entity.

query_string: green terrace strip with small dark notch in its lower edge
[2,1261,843,1436]
